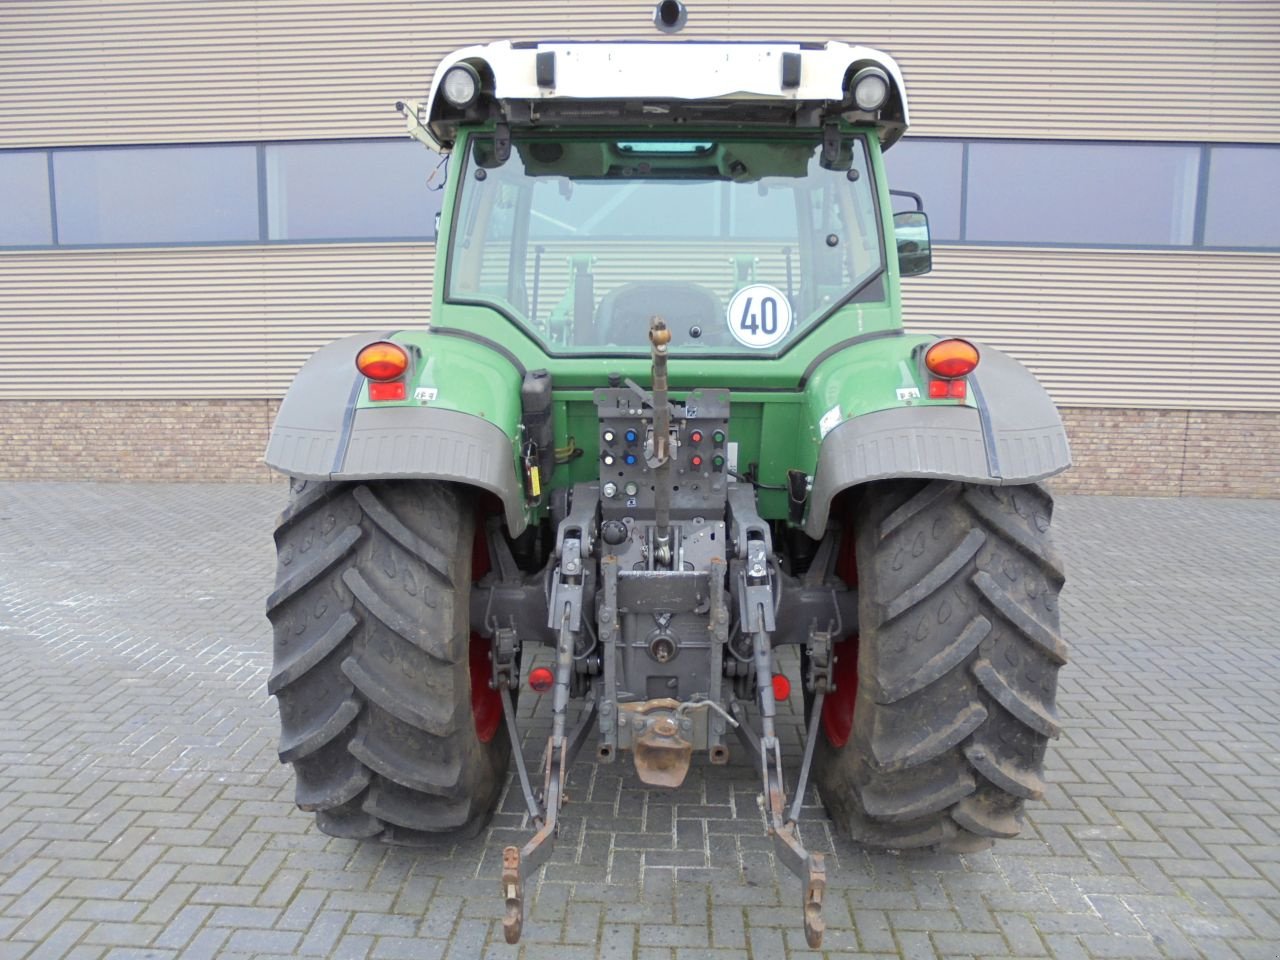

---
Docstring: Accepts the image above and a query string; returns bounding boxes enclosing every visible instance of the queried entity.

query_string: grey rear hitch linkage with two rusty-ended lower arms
[485,316,849,947]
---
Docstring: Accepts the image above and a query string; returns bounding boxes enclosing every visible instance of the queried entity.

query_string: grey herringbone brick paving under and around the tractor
[0,484,1280,960]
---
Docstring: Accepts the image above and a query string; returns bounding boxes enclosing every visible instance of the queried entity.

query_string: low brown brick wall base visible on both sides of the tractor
[0,399,1280,497]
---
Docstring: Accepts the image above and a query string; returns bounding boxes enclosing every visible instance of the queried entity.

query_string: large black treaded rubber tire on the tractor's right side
[814,480,1068,851]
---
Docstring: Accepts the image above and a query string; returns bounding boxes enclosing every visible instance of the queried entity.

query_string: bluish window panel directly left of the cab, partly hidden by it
[266,140,444,241]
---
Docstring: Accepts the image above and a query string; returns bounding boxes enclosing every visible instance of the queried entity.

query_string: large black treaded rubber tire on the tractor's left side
[266,480,511,844]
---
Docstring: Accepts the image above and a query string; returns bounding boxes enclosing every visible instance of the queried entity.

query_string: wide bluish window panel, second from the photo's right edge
[965,141,1199,246]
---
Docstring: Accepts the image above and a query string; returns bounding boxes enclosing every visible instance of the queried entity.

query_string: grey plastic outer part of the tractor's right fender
[804,344,1071,538]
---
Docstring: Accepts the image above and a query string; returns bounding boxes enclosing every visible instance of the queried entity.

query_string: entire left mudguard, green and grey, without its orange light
[264,330,529,536]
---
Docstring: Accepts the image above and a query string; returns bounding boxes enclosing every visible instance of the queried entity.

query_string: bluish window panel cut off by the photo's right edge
[1204,147,1280,247]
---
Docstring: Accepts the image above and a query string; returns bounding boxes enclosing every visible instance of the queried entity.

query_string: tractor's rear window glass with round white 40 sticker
[448,138,883,356]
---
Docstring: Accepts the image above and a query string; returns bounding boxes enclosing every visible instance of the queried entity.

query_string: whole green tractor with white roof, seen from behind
[259,0,1070,945]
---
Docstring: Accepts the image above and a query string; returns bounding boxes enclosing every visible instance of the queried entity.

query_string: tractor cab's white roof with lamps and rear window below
[401,32,908,360]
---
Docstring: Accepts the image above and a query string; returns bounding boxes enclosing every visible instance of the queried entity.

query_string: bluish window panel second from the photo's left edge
[54,146,259,243]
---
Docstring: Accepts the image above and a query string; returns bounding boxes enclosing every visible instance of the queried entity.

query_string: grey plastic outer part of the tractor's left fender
[262,333,527,536]
